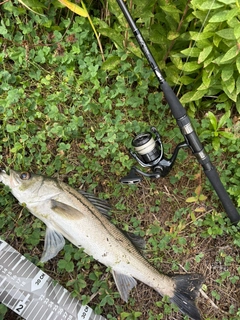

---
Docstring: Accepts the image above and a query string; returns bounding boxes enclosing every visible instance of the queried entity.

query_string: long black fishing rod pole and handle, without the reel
[117,0,240,223]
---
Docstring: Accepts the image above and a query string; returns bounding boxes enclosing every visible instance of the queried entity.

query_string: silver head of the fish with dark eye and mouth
[0,170,43,203]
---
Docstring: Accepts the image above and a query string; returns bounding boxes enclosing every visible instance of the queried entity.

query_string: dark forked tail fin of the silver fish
[170,274,204,320]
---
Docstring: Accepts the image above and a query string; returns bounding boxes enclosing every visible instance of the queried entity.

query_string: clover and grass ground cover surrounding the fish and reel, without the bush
[0,2,240,320]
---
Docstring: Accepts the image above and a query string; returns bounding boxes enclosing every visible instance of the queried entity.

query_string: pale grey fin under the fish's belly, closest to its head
[40,226,65,262]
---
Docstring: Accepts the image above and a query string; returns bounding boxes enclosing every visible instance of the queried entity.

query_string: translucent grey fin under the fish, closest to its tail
[112,270,137,302]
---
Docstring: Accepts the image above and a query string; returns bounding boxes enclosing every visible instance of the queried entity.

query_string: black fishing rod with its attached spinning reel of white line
[117,0,240,224]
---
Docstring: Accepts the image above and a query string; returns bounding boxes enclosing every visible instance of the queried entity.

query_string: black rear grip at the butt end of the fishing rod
[204,167,240,224]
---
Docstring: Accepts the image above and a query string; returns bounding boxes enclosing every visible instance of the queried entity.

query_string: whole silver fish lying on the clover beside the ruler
[0,170,203,320]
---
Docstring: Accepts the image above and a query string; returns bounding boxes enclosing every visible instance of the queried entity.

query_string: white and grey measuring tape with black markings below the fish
[0,239,106,320]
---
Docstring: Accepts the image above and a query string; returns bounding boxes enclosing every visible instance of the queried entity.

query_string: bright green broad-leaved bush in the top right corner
[175,0,240,113]
